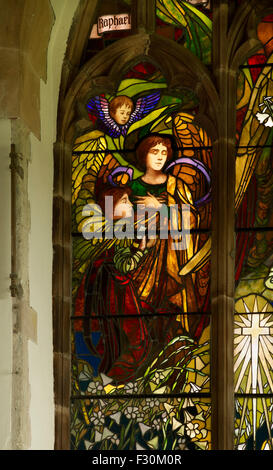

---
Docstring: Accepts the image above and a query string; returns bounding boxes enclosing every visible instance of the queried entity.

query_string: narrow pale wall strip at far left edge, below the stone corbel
[0,119,12,450]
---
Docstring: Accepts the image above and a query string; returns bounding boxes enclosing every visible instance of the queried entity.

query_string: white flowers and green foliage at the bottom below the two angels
[71,336,210,450]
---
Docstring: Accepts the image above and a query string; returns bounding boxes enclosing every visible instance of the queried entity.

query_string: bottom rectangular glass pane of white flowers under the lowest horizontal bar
[71,396,211,451]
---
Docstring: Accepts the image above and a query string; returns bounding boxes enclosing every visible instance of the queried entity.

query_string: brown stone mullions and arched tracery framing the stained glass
[53,0,272,450]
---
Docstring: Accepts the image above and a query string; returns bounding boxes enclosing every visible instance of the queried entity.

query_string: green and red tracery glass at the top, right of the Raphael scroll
[156,0,212,64]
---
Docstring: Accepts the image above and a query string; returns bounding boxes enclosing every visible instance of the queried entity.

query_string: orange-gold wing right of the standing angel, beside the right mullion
[173,113,212,307]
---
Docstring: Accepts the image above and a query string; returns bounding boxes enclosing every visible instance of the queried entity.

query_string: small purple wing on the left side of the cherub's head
[87,96,121,137]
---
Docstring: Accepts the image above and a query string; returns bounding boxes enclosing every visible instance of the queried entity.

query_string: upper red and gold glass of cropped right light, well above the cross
[235,15,273,228]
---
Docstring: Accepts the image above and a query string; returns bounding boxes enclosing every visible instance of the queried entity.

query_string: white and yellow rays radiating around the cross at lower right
[234,294,273,449]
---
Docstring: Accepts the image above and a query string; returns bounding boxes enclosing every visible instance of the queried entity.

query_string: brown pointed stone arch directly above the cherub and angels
[58,34,220,141]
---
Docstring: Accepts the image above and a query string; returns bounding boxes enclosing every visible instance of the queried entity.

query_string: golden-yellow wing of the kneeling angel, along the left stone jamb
[72,131,136,293]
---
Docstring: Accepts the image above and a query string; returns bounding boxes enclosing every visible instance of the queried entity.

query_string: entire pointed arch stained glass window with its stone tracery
[54,0,273,450]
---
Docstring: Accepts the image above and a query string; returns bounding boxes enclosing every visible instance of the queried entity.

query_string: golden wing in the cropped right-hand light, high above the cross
[235,53,273,209]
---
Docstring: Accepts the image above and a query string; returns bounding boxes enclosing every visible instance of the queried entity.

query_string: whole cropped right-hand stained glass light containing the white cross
[234,15,273,450]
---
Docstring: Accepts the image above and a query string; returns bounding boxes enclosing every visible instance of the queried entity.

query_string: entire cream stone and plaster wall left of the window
[0,0,79,449]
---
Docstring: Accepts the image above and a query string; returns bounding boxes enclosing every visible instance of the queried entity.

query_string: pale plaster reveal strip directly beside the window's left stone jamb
[27,0,79,450]
